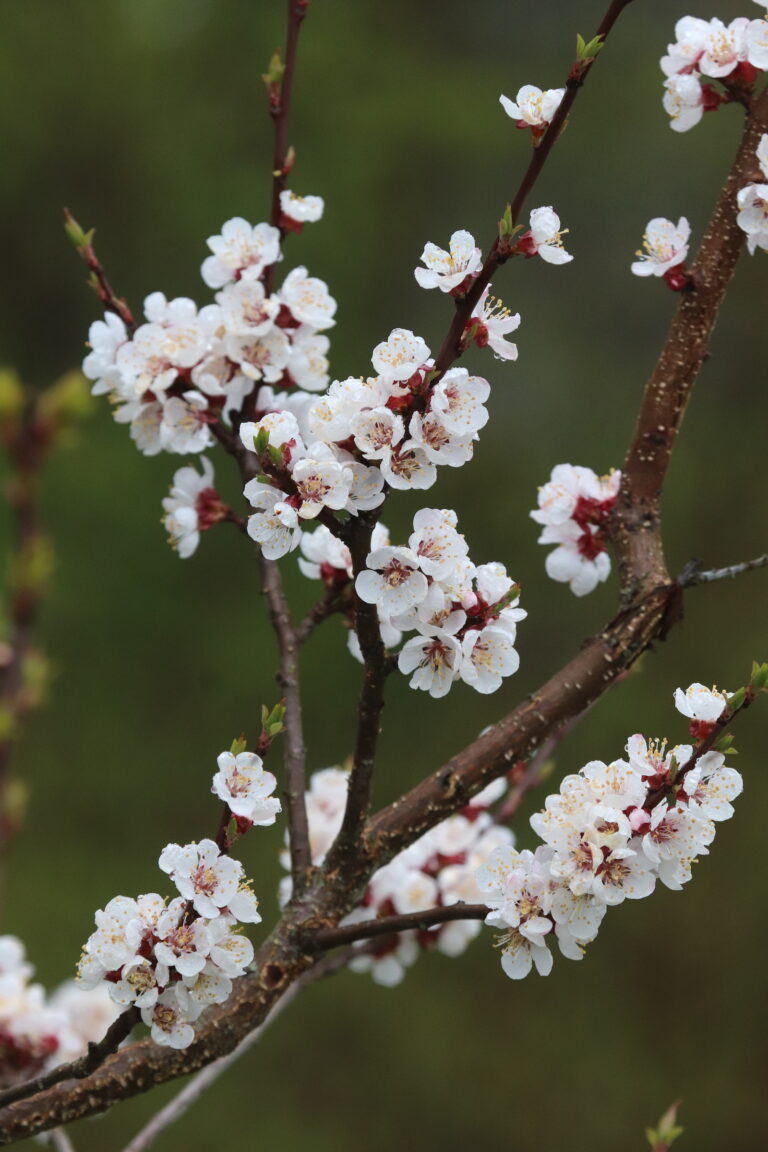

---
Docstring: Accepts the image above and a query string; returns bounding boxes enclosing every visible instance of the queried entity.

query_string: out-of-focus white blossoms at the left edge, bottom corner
[0,935,117,1089]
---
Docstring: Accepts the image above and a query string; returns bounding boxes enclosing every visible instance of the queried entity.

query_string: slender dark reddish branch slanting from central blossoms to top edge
[435,0,632,373]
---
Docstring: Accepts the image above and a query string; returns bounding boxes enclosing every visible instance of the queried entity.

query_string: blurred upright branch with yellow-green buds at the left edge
[0,369,92,916]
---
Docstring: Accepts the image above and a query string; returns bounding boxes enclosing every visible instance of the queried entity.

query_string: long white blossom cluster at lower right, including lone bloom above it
[476,684,743,979]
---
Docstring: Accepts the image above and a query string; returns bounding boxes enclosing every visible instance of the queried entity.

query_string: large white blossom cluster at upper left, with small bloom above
[83,205,336,456]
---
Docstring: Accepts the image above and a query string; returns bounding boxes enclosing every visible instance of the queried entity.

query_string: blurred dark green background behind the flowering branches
[0,0,768,1152]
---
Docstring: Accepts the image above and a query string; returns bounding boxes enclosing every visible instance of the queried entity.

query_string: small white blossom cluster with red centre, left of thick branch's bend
[531,464,622,596]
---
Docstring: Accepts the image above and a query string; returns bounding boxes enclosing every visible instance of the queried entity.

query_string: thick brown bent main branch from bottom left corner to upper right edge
[7,6,768,1144]
